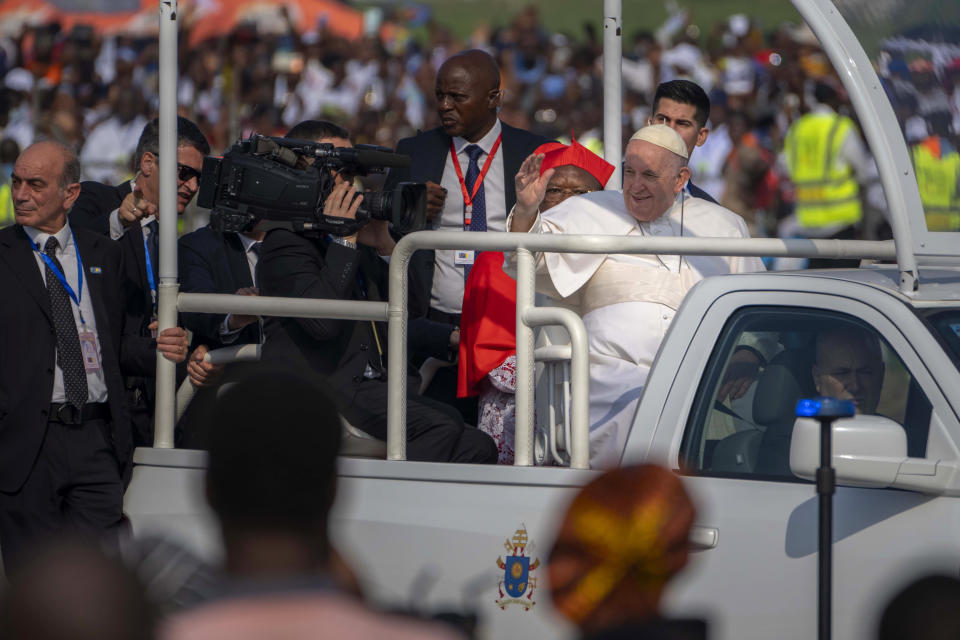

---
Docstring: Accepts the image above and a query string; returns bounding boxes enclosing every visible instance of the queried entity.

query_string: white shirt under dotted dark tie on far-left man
[23,225,107,403]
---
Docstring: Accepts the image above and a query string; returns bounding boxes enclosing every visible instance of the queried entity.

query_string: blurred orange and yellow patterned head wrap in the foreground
[548,465,694,628]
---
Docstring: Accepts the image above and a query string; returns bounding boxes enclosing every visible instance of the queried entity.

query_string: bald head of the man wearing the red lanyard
[436,49,501,142]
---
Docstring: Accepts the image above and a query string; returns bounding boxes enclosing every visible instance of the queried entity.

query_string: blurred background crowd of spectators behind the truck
[0,0,960,235]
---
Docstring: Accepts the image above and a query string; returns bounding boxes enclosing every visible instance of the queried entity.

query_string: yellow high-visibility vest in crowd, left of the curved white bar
[784,113,863,228]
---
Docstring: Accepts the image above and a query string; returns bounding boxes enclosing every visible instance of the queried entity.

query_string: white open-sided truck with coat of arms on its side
[125,0,960,640]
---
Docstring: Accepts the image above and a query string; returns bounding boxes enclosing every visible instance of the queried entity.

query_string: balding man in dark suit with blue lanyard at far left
[0,142,139,571]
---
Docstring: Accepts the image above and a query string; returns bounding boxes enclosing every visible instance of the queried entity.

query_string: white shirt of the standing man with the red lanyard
[430,120,512,313]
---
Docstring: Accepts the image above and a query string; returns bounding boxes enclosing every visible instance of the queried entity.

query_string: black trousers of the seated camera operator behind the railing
[331,378,497,464]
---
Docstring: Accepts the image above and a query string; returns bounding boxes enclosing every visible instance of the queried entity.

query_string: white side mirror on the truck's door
[790,415,908,487]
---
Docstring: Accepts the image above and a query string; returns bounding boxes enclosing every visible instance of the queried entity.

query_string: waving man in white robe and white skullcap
[507,124,764,467]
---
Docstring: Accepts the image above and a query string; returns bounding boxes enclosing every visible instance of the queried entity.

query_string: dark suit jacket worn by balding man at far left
[0,225,131,492]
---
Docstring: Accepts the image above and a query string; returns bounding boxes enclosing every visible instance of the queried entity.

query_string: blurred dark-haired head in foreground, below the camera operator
[207,371,341,576]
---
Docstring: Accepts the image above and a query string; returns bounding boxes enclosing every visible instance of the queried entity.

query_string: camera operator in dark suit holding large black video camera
[259,121,497,464]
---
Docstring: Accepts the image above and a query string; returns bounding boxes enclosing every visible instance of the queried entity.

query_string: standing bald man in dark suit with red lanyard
[385,49,548,422]
